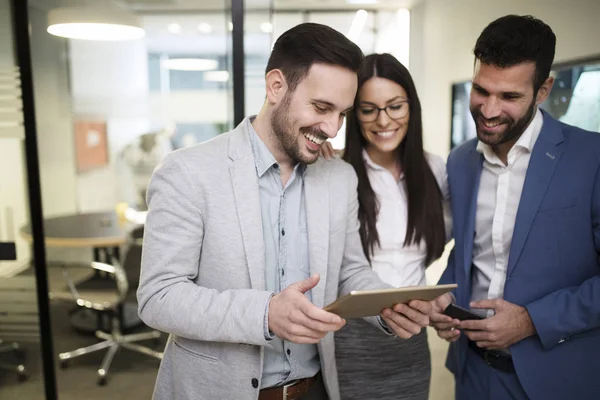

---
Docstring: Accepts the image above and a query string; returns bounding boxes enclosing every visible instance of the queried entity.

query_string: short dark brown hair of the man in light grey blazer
[265,23,363,91]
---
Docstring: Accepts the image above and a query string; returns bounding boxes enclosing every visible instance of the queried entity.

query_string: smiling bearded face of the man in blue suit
[470,61,552,147]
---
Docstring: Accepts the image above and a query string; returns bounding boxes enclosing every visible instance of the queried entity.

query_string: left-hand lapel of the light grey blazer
[229,121,265,290]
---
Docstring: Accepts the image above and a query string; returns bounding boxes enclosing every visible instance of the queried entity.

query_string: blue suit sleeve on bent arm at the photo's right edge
[526,163,600,349]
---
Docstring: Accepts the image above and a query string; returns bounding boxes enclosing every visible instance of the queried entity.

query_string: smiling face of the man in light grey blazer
[270,64,357,164]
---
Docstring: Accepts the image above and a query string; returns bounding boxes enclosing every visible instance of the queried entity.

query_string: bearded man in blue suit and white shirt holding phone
[430,15,600,400]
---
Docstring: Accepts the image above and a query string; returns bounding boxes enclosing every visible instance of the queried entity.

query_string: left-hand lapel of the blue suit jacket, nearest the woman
[463,148,483,282]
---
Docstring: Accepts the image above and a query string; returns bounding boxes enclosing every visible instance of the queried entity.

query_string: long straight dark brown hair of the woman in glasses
[343,54,446,265]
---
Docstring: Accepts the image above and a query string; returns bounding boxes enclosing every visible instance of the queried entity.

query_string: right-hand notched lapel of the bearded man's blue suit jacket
[506,113,563,276]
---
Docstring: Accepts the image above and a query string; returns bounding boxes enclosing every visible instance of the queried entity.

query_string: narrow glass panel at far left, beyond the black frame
[0,0,52,400]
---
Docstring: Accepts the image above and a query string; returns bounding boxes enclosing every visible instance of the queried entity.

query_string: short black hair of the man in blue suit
[473,15,556,92]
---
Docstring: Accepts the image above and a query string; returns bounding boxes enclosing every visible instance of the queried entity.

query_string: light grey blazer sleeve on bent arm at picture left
[137,152,271,346]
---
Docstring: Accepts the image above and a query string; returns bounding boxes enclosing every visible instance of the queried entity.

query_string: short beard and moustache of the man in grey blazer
[271,93,327,164]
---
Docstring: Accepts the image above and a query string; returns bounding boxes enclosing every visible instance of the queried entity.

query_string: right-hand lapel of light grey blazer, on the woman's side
[304,162,330,307]
